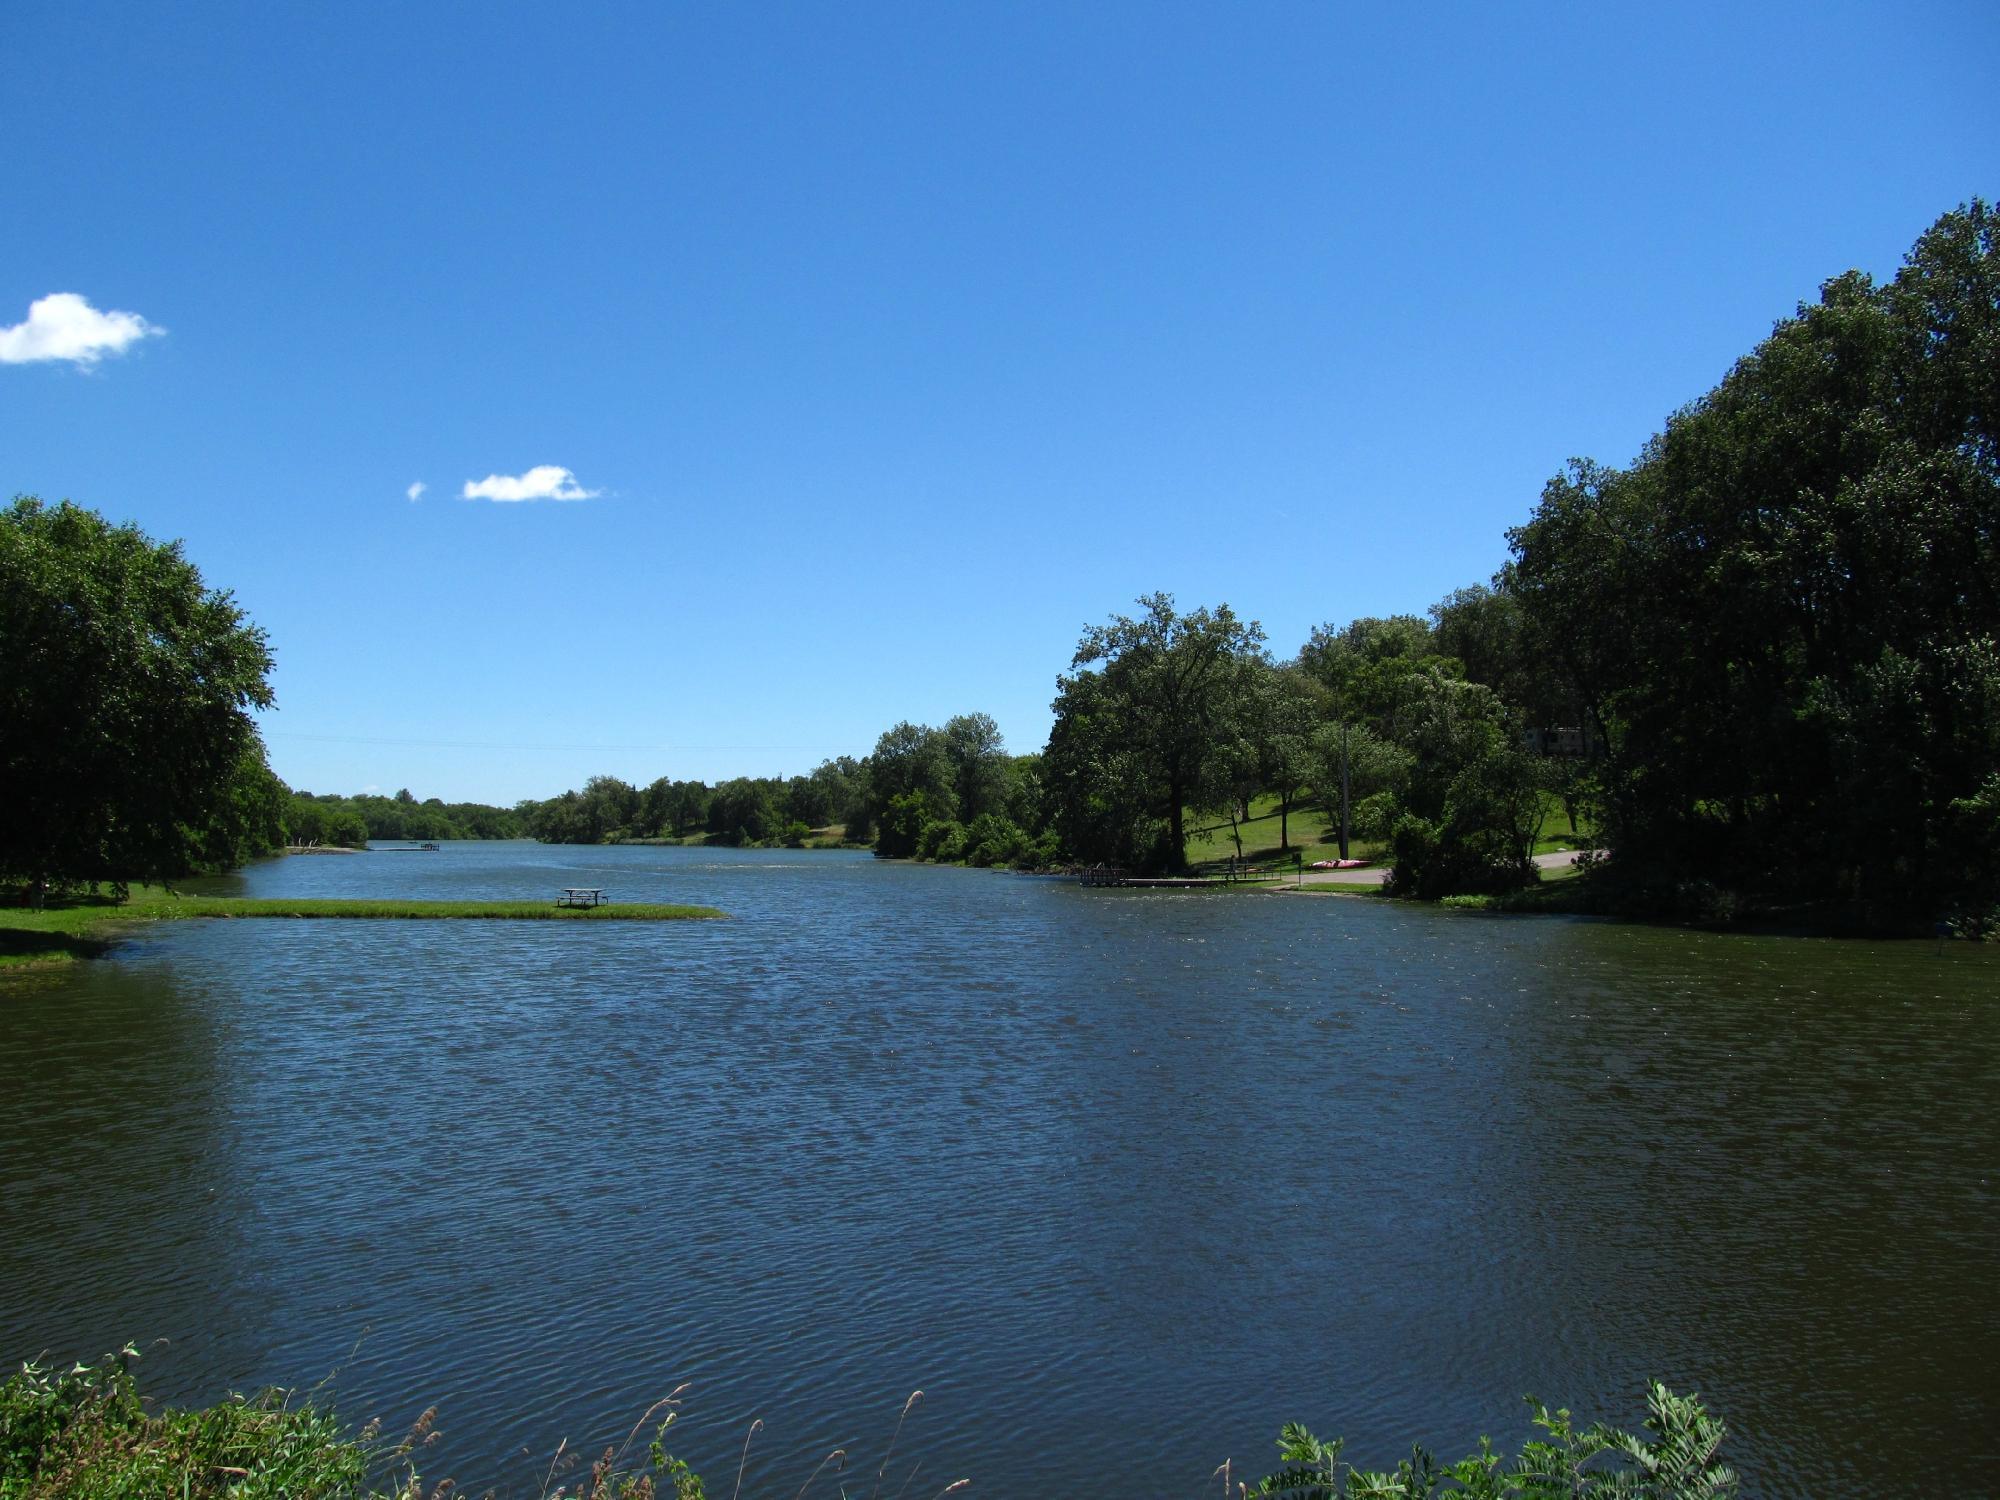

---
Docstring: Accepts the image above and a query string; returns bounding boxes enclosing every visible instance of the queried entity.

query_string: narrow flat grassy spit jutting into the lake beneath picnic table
[0,886,724,968]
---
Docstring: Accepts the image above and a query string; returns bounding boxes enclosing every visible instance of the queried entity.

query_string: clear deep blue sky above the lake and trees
[0,0,2000,802]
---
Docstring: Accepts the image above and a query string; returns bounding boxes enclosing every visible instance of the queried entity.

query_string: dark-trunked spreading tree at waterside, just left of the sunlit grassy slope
[1048,594,1264,870]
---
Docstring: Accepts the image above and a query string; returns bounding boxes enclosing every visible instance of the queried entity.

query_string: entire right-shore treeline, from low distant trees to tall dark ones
[522,202,2000,928]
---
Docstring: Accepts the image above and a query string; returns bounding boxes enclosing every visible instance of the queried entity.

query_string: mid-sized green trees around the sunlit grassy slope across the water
[1046,590,1560,896]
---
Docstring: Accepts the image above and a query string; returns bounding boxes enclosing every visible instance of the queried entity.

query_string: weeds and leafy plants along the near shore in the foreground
[0,1348,1738,1500]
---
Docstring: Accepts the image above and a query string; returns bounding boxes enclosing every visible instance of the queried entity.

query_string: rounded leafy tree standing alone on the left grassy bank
[0,498,272,888]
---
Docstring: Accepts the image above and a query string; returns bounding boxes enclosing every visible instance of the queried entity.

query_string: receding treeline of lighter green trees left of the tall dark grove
[520,588,1578,894]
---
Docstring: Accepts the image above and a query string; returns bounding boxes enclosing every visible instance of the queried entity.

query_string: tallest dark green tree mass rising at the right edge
[1506,202,2000,918]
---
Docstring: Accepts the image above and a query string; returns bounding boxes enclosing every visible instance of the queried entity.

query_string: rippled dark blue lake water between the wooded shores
[0,844,2000,1498]
